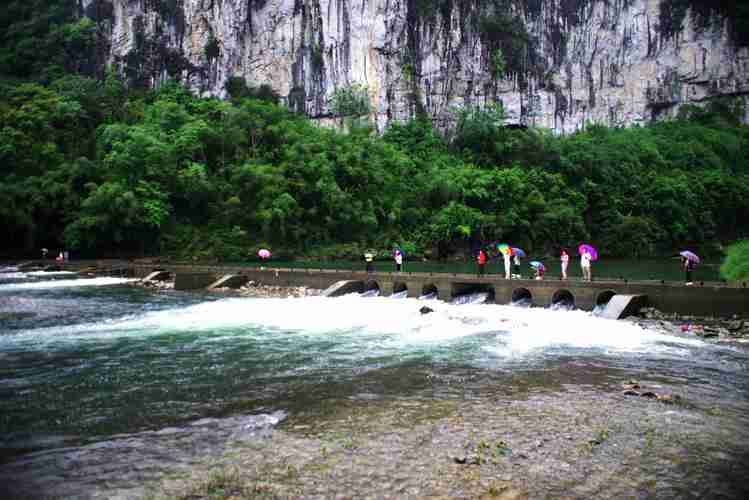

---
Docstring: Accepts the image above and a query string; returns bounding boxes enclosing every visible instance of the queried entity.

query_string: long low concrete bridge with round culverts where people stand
[93,264,749,317]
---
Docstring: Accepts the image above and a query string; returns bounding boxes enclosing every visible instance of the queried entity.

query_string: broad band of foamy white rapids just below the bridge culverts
[0,292,706,358]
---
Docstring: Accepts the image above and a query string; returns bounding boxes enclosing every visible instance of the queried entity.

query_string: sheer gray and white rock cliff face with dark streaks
[81,0,749,133]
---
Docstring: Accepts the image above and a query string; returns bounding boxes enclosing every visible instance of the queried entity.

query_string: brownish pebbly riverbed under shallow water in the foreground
[6,374,749,499]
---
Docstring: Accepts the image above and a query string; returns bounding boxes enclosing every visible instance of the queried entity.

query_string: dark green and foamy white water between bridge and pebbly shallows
[0,273,749,496]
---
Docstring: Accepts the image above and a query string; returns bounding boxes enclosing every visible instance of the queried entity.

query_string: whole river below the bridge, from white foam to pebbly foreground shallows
[0,273,749,498]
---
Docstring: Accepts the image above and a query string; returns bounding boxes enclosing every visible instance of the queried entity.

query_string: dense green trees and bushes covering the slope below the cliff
[0,0,749,260]
